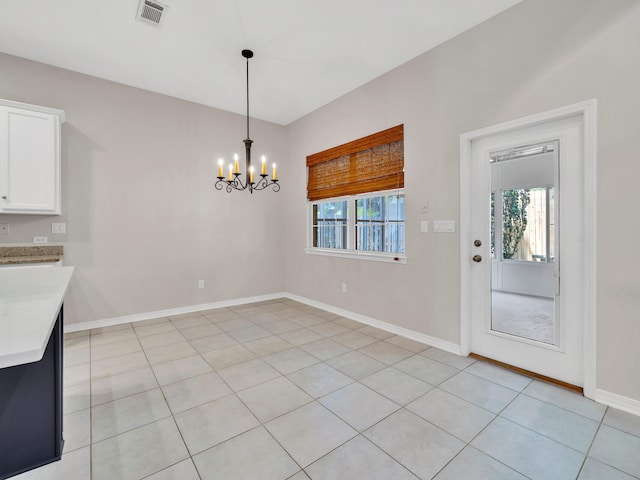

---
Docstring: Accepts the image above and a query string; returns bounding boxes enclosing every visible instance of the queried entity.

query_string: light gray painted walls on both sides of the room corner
[0,0,640,400]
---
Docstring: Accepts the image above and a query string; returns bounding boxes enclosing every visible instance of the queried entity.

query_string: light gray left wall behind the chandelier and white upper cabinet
[0,54,287,323]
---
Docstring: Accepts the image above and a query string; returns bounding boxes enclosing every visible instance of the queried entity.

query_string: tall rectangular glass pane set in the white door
[490,142,557,345]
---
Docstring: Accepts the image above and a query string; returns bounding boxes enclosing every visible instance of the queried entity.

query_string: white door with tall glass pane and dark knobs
[461,112,585,386]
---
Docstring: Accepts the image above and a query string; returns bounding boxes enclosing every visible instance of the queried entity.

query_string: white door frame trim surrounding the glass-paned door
[460,99,597,398]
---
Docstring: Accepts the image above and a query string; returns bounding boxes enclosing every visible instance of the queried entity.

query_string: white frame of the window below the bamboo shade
[305,188,408,264]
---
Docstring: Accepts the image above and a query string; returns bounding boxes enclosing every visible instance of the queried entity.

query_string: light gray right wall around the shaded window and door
[285,0,640,400]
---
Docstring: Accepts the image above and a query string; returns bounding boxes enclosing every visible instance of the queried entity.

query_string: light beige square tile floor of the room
[15,299,640,480]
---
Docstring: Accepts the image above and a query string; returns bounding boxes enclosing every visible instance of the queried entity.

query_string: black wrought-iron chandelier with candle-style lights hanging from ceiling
[215,50,280,193]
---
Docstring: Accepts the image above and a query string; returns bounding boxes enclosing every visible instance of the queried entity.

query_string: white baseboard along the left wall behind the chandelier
[64,292,287,333]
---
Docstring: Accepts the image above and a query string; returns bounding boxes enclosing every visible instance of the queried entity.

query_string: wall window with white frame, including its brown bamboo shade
[307,125,405,261]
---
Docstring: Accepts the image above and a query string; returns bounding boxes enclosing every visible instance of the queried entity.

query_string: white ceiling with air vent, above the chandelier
[0,0,521,125]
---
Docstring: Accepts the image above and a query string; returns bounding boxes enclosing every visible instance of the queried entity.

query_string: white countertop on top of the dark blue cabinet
[0,267,74,368]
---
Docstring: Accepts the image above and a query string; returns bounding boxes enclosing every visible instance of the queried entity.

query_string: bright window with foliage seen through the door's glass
[491,187,555,262]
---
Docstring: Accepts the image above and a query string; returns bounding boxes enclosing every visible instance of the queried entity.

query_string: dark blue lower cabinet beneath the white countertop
[0,308,64,479]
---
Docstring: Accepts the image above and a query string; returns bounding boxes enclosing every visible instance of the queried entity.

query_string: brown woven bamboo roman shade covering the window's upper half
[307,125,404,201]
